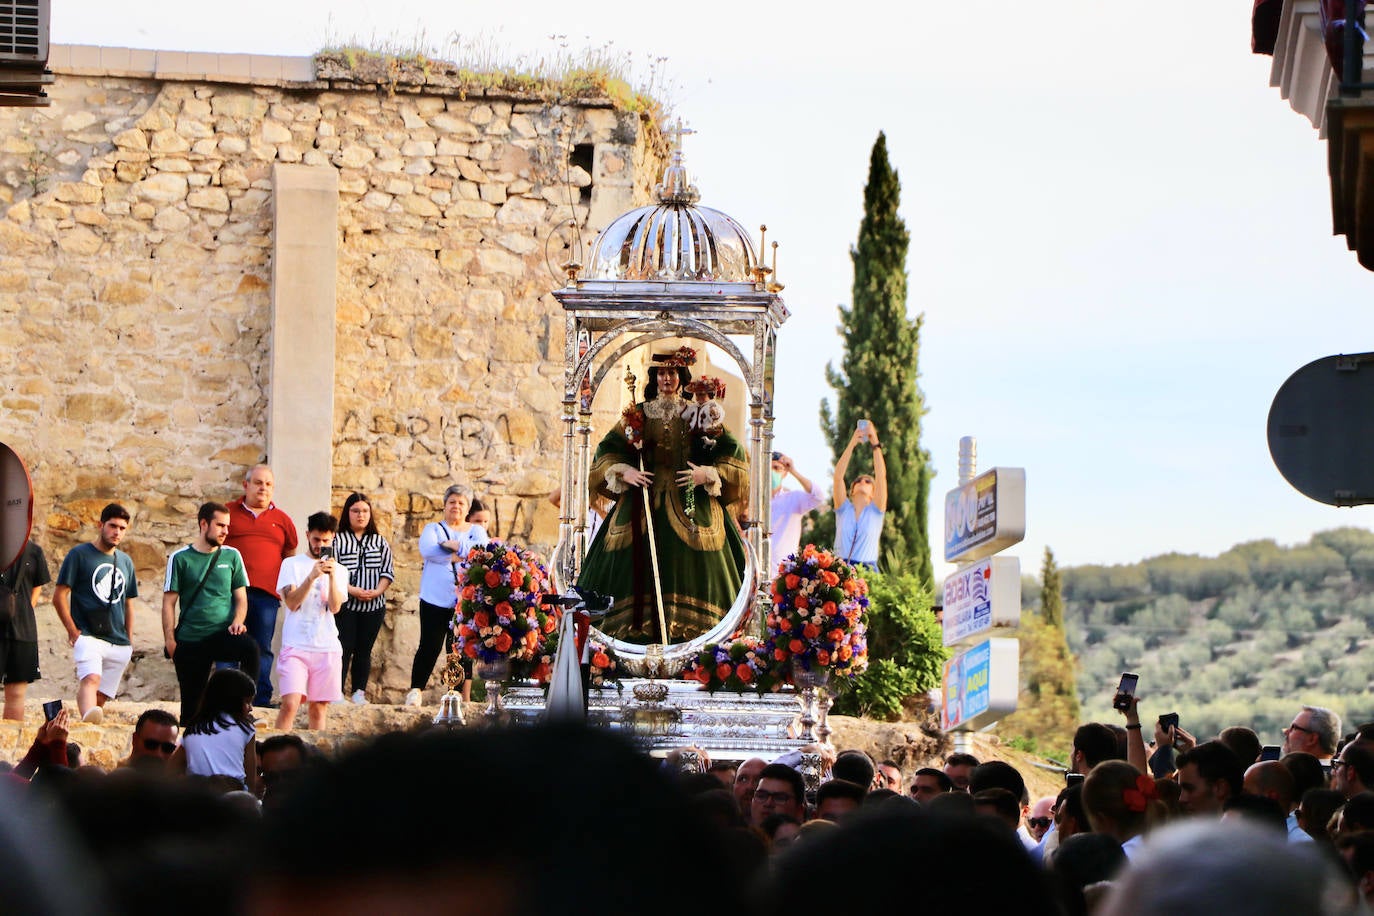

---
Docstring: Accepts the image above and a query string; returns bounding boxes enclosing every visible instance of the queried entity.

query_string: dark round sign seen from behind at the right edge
[1268,353,1374,505]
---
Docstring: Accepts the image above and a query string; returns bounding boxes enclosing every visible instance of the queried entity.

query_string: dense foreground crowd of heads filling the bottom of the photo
[0,697,1374,916]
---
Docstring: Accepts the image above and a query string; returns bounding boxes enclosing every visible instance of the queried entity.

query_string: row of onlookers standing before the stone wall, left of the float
[0,464,519,729]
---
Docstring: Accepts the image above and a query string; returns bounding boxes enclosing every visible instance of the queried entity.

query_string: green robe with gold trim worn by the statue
[577,398,749,643]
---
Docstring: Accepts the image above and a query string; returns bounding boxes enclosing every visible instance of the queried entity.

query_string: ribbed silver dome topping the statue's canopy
[583,146,758,283]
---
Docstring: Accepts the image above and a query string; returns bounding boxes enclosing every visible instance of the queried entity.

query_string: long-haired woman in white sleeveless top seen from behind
[172,667,257,794]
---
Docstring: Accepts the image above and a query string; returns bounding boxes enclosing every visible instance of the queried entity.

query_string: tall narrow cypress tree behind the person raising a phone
[815,133,934,592]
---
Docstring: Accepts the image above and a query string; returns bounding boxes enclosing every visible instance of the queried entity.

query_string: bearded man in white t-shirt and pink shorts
[276,512,348,731]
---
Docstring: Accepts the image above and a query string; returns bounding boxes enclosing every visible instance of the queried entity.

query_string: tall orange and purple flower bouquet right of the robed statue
[765,544,868,677]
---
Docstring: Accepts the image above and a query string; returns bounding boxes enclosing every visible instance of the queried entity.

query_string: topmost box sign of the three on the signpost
[944,467,1026,563]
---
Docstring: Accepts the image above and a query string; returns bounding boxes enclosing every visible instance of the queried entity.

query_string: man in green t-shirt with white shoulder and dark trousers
[162,503,258,725]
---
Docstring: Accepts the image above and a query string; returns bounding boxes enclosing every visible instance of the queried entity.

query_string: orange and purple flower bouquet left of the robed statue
[452,541,562,680]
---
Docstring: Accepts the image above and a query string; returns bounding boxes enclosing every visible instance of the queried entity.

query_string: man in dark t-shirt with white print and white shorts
[52,503,139,725]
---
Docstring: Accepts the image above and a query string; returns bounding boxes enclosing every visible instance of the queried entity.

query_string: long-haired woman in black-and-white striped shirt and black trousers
[334,493,396,705]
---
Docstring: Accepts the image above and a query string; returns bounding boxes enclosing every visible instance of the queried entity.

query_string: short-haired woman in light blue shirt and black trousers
[405,483,491,706]
